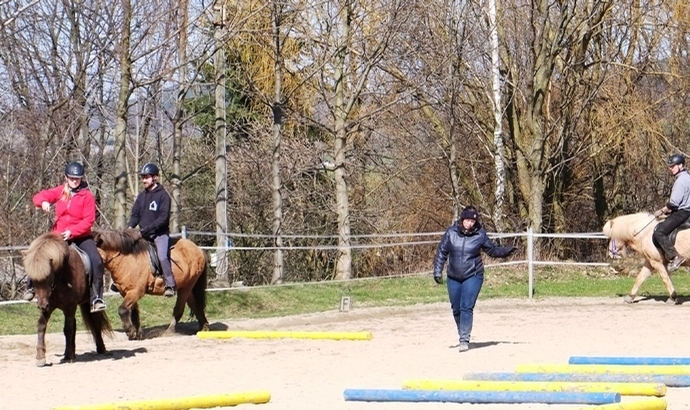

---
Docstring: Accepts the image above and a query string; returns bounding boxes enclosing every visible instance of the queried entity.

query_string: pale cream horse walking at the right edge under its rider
[604,212,690,305]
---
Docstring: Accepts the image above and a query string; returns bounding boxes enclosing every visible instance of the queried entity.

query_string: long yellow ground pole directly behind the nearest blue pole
[403,380,666,397]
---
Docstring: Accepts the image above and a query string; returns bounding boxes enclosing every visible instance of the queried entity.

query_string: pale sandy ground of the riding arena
[0,298,690,410]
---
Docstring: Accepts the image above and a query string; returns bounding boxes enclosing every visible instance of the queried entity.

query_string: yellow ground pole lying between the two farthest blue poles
[515,364,690,375]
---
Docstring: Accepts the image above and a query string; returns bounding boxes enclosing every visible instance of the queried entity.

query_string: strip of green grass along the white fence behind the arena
[5,267,690,335]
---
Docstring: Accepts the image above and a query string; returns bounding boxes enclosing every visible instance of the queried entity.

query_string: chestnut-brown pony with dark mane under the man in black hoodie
[94,228,208,340]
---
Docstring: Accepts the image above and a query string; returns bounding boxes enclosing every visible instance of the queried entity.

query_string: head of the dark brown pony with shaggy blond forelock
[23,232,69,309]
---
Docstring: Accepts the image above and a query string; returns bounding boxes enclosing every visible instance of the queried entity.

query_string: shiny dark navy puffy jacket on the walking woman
[434,222,513,281]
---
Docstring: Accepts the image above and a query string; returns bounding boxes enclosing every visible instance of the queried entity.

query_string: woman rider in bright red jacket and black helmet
[24,162,106,312]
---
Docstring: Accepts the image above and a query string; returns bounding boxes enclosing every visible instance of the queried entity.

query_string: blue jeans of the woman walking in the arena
[446,274,484,343]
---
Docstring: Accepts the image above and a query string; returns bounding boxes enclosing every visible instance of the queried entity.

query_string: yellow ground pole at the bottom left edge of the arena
[53,390,271,410]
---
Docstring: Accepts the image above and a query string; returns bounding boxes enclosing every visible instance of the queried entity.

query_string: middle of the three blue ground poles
[463,373,690,387]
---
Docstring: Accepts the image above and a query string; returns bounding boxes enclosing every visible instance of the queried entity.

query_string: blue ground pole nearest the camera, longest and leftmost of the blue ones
[343,389,621,404]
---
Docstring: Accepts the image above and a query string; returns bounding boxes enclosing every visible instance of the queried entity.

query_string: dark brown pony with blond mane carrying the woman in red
[23,233,112,367]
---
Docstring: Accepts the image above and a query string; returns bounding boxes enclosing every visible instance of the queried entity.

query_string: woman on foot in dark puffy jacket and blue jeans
[434,206,517,352]
